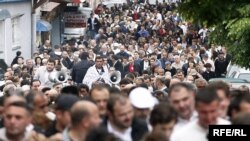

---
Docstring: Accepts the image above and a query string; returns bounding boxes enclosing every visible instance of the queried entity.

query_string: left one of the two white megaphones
[49,71,68,83]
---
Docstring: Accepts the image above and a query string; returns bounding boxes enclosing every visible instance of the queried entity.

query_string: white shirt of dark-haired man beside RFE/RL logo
[170,118,230,141]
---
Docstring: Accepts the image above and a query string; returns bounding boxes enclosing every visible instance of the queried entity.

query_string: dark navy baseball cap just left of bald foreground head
[55,94,79,111]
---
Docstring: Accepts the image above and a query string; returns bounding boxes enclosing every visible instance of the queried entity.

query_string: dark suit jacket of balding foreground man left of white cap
[101,118,148,141]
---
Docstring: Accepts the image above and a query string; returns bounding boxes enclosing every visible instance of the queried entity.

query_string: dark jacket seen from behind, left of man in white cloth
[71,60,93,84]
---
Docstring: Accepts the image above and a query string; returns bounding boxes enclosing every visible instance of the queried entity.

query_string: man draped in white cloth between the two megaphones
[82,56,111,88]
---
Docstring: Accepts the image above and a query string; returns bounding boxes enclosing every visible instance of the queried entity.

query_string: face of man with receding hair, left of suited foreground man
[91,89,109,116]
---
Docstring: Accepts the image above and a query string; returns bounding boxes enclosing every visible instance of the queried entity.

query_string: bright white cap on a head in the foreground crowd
[129,87,158,109]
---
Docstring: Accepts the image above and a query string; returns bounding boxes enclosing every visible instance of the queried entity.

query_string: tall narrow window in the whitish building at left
[11,16,21,47]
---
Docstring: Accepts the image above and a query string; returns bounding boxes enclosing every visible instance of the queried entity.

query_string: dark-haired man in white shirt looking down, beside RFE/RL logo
[171,87,230,141]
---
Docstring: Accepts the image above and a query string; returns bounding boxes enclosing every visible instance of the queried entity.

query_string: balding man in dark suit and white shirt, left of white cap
[102,94,148,141]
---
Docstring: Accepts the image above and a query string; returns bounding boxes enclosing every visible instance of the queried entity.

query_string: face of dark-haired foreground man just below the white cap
[153,120,176,138]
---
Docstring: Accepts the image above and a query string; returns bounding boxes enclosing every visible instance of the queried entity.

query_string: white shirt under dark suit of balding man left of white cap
[108,121,133,141]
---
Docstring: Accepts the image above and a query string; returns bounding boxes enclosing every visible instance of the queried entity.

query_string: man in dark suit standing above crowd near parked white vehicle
[87,13,100,39]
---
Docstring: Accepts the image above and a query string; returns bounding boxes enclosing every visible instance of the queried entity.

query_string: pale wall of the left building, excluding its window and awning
[0,2,32,65]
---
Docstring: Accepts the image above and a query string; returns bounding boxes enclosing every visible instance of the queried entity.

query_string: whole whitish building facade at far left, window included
[0,0,33,65]
